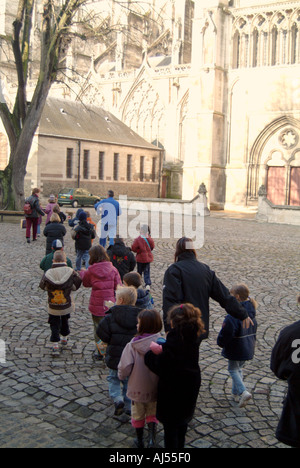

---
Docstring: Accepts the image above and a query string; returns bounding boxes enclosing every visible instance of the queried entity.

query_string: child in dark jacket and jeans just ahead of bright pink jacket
[72,211,96,271]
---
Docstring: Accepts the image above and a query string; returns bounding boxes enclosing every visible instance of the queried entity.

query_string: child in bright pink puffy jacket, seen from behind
[79,244,122,360]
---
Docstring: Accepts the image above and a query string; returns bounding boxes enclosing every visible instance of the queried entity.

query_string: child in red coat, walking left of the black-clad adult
[131,224,155,289]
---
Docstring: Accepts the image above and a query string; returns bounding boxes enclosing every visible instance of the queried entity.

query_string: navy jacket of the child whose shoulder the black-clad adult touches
[217,300,257,361]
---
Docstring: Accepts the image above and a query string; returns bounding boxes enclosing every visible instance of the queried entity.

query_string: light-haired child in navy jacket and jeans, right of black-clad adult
[217,284,257,408]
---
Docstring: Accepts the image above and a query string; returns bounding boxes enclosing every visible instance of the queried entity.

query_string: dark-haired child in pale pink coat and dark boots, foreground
[118,309,162,448]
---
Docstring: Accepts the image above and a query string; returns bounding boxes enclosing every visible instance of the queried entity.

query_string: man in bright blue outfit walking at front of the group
[95,190,122,247]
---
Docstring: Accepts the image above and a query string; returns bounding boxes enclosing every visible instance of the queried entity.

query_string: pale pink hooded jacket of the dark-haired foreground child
[118,333,161,403]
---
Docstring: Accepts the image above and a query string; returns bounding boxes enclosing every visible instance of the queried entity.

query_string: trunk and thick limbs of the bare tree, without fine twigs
[0,0,94,209]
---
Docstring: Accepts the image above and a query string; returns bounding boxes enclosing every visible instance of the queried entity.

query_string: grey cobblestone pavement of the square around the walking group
[0,215,300,448]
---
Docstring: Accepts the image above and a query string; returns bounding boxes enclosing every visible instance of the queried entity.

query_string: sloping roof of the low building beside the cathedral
[38,98,159,150]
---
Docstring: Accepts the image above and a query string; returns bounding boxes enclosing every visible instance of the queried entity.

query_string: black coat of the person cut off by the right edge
[271,321,300,448]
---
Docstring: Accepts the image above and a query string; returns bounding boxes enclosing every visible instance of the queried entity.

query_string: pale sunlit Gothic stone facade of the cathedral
[2,0,300,209]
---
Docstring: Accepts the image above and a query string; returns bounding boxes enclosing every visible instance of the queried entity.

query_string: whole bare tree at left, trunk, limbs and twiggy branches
[0,0,166,209]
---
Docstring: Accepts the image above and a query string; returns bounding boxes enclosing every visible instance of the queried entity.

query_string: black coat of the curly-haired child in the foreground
[145,329,201,425]
